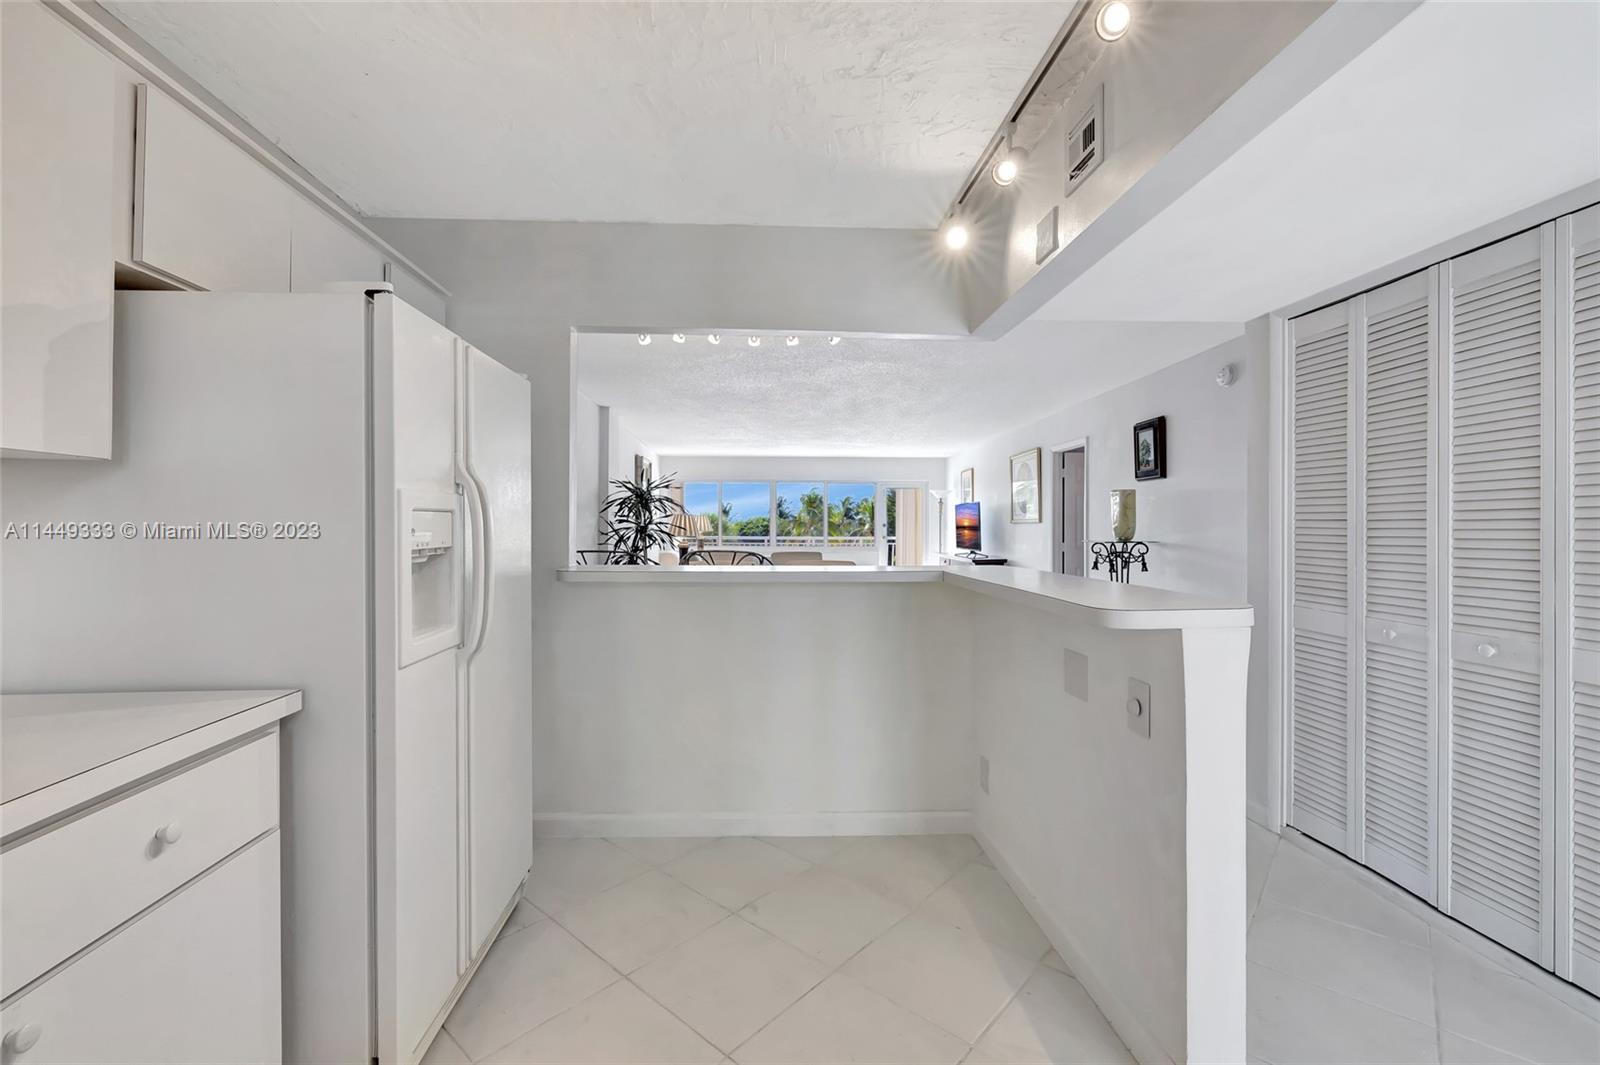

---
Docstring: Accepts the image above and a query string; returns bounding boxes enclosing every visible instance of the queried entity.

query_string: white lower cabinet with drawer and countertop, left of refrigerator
[0,691,301,1065]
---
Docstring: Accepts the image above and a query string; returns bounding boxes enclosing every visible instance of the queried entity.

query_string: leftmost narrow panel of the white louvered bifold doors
[1288,304,1357,851]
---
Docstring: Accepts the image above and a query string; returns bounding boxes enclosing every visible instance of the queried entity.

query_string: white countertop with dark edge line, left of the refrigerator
[0,689,301,835]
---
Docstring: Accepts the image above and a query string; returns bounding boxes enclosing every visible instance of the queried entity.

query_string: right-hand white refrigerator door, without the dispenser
[461,345,533,956]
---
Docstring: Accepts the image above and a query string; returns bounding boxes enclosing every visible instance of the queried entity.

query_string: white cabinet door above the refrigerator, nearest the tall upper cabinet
[133,86,296,293]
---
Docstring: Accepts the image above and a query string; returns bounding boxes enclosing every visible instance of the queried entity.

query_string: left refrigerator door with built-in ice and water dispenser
[373,294,466,1065]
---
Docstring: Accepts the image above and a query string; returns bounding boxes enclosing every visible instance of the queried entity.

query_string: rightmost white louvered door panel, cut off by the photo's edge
[1557,208,1600,993]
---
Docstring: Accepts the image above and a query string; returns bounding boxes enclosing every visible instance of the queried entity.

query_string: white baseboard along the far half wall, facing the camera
[533,809,973,840]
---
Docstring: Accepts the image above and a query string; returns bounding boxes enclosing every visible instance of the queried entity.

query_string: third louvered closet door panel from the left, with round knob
[1442,224,1555,966]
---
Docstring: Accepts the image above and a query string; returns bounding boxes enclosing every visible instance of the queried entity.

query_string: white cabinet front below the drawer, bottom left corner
[0,832,283,1065]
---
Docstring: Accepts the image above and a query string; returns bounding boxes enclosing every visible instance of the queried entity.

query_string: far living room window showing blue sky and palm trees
[683,481,878,550]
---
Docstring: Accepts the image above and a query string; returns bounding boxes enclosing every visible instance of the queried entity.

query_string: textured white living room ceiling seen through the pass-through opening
[578,321,1242,457]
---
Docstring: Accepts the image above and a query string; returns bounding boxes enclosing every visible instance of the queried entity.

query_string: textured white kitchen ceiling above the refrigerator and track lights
[106,0,1072,229]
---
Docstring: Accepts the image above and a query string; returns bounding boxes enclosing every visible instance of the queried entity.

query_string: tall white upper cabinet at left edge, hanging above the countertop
[0,3,115,459]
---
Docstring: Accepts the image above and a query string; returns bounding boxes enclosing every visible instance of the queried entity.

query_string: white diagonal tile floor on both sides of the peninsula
[426,825,1600,1065]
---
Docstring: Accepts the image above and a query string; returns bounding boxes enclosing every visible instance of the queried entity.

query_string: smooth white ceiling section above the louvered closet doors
[1035,0,1600,321]
